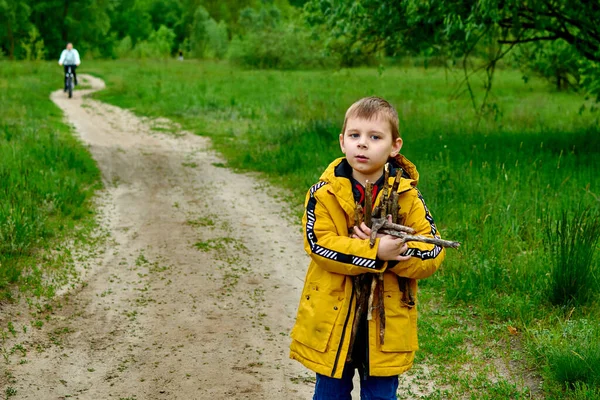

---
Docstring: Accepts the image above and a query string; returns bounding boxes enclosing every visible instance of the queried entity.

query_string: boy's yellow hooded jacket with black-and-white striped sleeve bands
[290,156,445,378]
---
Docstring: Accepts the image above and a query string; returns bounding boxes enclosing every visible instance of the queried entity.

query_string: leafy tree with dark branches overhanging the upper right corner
[305,0,600,96]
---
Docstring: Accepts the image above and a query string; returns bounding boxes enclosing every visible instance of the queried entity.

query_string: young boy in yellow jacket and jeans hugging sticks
[290,97,445,400]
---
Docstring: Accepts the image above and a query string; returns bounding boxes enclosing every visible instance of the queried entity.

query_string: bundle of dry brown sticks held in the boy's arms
[348,163,460,358]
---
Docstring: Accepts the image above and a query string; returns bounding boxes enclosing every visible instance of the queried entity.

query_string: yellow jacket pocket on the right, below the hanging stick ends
[381,291,418,353]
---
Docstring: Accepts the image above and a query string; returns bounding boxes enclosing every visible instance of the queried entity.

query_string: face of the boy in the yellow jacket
[340,116,402,185]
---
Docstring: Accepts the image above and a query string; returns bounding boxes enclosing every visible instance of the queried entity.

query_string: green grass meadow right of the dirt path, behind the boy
[86,61,600,398]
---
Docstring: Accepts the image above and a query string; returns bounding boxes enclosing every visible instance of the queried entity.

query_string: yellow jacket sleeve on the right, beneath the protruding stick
[388,189,446,279]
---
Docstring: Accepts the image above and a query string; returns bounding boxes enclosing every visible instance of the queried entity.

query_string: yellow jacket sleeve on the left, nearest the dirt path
[302,182,387,275]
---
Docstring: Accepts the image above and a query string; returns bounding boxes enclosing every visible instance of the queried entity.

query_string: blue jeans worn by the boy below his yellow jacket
[313,363,398,400]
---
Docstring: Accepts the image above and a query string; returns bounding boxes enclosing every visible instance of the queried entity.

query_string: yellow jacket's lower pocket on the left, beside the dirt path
[291,290,343,353]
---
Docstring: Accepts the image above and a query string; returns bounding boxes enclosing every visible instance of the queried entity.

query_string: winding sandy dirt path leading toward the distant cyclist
[3,75,312,400]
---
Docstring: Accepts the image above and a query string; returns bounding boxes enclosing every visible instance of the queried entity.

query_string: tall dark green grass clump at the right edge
[545,209,600,305]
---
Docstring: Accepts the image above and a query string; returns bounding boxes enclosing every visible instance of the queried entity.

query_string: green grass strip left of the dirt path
[0,62,99,301]
